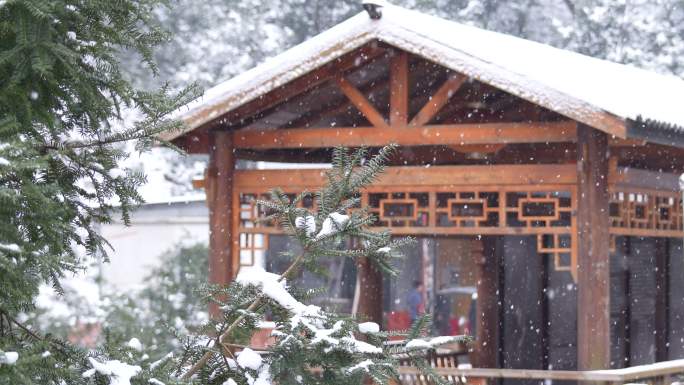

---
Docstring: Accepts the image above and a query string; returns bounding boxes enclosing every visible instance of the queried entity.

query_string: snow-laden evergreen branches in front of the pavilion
[172,146,470,385]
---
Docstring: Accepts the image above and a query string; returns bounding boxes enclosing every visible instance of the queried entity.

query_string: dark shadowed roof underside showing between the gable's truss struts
[232,49,562,130]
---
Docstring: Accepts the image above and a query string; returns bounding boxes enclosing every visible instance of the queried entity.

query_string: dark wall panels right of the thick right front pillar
[610,237,684,368]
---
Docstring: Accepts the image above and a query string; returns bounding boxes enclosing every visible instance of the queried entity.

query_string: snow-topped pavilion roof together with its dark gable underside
[164,6,684,146]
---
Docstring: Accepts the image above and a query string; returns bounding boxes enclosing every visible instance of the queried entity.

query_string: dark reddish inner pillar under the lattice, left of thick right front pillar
[472,237,501,368]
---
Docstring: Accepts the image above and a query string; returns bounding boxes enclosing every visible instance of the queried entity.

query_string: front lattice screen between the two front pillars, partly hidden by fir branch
[234,164,577,277]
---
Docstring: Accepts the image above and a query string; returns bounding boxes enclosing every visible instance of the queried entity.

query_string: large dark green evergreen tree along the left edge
[0,0,197,384]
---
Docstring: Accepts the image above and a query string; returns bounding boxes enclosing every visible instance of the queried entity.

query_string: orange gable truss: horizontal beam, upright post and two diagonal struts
[228,47,577,150]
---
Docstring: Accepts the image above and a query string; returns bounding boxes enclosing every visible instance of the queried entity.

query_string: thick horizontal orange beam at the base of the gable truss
[234,121,577,149]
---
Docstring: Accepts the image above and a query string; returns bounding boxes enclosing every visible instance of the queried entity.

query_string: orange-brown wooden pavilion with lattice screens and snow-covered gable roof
[165,6,684,376]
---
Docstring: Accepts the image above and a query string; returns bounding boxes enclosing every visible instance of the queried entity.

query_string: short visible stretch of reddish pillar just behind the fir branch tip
[356,257,382,325]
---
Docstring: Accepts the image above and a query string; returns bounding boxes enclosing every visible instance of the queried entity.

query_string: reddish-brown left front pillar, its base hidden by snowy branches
[207,131,235,315]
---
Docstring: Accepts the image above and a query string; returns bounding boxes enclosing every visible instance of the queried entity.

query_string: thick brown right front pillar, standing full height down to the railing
[577,125,610,370]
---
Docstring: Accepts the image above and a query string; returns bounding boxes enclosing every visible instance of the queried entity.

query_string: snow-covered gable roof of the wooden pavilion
[164,5,684,143]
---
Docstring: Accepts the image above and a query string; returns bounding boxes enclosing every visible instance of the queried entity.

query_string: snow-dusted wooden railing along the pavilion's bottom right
[399,359,684,385]
